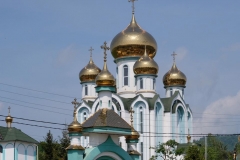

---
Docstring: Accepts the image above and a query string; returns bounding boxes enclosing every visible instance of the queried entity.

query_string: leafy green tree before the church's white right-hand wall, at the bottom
[150,140,184,160]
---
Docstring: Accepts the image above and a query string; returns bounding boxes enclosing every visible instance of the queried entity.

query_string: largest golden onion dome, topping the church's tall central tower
[110,14,157,58]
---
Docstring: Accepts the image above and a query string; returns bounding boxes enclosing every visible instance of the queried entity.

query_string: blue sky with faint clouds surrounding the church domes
[0,0,240,141]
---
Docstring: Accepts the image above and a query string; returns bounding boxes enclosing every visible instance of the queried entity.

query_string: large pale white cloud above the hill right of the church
[194,91,240,134]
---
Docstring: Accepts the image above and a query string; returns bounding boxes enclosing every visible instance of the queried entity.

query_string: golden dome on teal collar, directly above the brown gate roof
[95,60,115,86]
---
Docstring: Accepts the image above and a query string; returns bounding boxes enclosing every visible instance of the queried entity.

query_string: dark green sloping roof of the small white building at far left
[0,126,38,143]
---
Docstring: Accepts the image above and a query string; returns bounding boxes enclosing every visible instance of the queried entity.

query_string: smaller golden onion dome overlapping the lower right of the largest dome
[133,49,158,74]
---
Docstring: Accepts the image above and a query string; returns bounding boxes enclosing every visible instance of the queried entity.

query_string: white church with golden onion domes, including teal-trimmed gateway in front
[67,0,193,160]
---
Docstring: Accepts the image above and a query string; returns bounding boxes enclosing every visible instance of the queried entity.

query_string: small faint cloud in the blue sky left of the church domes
[57,45,77,65]
